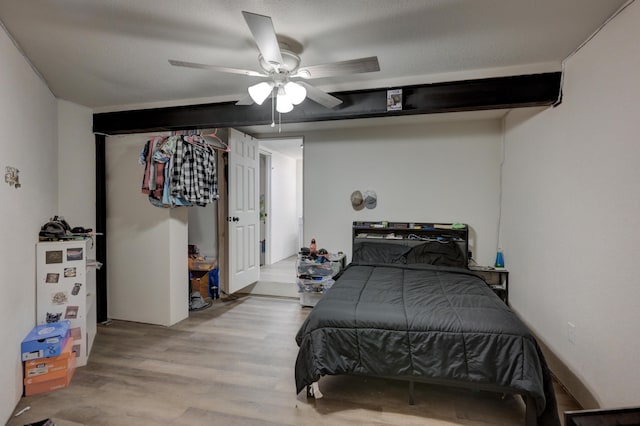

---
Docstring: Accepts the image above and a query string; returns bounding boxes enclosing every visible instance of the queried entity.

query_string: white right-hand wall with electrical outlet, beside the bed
[502,2,640,408]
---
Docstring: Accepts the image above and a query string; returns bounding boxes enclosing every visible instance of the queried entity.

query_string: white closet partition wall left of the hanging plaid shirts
[106,134,189,326]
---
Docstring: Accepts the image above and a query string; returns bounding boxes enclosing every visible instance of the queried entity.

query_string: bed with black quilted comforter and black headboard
[295,223,560,426]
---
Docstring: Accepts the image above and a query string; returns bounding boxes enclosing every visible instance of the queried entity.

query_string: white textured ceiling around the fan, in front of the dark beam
[0,0,627,112]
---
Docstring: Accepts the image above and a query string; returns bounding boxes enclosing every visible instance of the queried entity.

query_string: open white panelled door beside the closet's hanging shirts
[227,129,260,293]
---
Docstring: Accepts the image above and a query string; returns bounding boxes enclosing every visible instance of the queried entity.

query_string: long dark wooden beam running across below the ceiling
[93,72,561,135]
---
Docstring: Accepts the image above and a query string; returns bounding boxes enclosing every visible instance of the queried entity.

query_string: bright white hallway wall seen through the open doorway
[271,152,301,263]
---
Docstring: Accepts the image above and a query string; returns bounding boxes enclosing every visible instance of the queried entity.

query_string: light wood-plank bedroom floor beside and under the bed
[8,296,579,426]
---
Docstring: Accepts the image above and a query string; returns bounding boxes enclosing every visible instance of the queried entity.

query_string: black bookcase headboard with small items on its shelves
[352,221,469,265]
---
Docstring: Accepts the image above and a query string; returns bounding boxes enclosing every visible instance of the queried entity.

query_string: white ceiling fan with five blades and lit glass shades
[169,11,380,114]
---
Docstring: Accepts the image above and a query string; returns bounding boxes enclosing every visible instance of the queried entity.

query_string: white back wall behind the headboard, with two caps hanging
[304,120,502,265]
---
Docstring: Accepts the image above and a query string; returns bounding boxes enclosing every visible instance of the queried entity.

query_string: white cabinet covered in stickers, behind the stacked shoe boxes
[36,239,97,367]
